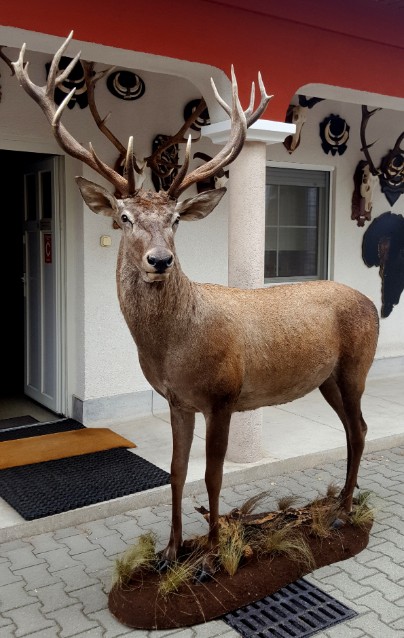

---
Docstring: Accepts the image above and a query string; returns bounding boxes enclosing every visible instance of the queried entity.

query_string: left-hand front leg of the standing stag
[159,406,195,571]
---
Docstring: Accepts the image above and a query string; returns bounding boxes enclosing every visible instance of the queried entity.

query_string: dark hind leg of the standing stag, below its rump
[319,376,367,513]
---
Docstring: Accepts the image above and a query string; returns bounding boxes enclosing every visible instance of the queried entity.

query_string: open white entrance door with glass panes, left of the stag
[23,157,64,413]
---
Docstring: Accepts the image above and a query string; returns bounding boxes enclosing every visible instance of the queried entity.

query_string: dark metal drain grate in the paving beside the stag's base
[223,578,357,638]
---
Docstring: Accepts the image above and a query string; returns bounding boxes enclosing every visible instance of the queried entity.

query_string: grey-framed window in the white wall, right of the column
[265,167,329,283]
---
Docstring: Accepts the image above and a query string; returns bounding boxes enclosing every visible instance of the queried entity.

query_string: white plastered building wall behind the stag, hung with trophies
[0,43,404,420]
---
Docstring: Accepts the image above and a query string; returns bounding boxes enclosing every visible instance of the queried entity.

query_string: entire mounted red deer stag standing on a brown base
[14,32,378,584]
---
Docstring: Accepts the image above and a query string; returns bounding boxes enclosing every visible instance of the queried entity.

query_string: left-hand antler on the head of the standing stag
[12,32,128,195]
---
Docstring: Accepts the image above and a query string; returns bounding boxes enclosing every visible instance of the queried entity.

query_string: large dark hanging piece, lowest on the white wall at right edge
[362,212,404,317]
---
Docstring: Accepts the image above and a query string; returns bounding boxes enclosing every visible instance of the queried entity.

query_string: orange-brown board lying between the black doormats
[0,428,136,470]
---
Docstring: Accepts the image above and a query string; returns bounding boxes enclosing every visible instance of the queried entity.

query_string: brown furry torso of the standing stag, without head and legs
[117,260,375,414]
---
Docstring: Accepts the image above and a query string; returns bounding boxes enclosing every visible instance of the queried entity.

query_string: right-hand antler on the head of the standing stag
[168,65,273,199]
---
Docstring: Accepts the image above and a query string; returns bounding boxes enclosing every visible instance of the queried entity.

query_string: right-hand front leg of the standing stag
[197,408,231,582]
